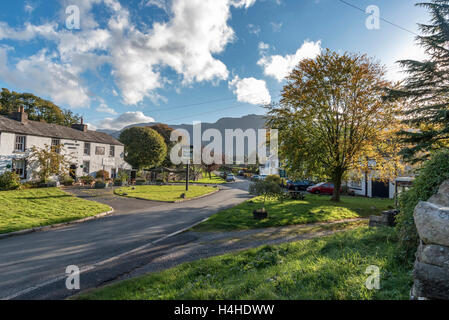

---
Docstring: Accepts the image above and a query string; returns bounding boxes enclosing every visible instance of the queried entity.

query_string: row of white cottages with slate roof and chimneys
[0,108,132,181]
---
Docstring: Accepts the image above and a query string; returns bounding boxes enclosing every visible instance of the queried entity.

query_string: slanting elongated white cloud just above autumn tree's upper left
[257,41,321,82]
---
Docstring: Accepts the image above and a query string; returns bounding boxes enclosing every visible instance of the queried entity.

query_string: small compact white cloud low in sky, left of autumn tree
[229,76,271,105]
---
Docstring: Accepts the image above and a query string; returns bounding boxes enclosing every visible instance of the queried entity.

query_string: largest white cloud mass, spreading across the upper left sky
[0,0,256,107]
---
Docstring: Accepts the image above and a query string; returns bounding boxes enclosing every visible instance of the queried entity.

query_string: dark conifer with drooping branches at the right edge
[388,0,449,161]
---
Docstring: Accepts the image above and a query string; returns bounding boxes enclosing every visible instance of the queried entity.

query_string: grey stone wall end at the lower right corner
[411,180,449,300]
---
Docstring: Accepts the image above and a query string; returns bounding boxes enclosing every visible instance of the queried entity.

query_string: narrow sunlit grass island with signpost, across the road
[114,185,217,202]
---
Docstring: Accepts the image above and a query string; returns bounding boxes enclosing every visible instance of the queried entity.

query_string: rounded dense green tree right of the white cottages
[120,127,167,170]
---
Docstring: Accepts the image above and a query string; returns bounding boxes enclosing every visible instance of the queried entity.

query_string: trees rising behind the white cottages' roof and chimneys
[0,88,80,126]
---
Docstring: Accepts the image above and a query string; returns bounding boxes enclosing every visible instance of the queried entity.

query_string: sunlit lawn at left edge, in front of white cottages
[0,188,111,233]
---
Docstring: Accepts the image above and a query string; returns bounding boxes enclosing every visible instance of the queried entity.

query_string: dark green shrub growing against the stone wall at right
[396,150,449,259]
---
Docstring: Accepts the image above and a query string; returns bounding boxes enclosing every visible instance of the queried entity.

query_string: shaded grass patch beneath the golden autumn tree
[195,195,394,231]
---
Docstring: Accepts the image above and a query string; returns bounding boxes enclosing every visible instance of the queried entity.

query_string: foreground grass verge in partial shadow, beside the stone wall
[78,227,412,300]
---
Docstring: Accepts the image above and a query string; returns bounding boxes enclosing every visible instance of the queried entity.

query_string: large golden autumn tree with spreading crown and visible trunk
[268,50,400,201]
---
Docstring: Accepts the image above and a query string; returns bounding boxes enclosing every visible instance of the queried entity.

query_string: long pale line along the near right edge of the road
[0,217,209,300]
